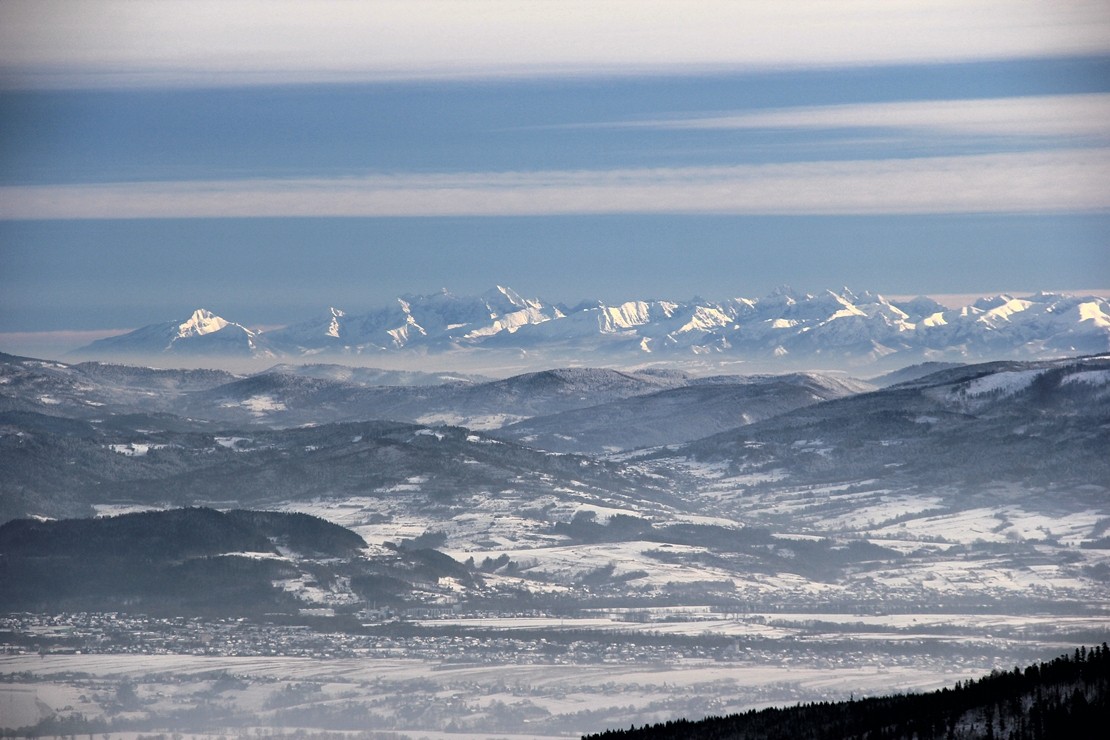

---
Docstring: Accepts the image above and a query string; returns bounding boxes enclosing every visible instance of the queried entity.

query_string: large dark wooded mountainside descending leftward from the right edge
[665,357,1110,490]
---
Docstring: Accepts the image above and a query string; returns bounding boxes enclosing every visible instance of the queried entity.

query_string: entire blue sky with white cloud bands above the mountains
[0,0,1110,352]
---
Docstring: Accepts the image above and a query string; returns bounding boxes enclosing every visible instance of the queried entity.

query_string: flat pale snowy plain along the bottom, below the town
[0,637,1078,738]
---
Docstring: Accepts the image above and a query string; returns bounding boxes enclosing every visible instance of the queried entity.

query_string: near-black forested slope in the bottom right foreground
[584,642,1110,740]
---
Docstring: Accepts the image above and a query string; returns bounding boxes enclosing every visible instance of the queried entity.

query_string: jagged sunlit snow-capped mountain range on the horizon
[74,286,1110,364]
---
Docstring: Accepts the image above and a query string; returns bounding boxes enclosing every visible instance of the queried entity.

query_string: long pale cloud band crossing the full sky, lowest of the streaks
[0,148,1110,220]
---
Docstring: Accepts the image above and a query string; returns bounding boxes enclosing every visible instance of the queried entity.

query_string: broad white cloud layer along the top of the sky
[0,0,1110,88]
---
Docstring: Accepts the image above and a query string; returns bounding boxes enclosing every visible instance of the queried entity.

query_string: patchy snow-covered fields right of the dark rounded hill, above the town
[268,469,1110,610]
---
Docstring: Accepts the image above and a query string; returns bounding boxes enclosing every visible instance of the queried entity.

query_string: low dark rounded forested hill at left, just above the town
[0,507,366,616]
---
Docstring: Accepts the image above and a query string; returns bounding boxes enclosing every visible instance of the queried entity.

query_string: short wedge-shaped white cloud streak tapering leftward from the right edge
[599,93,1110,140]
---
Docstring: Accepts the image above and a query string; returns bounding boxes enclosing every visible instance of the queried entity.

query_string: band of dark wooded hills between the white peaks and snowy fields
[0,355,1110,521]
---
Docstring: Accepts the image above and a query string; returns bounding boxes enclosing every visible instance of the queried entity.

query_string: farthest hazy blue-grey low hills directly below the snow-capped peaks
[0,354,874,437]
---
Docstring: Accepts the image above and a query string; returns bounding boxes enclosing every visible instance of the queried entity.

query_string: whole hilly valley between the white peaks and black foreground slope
[0,356,1110,737]
